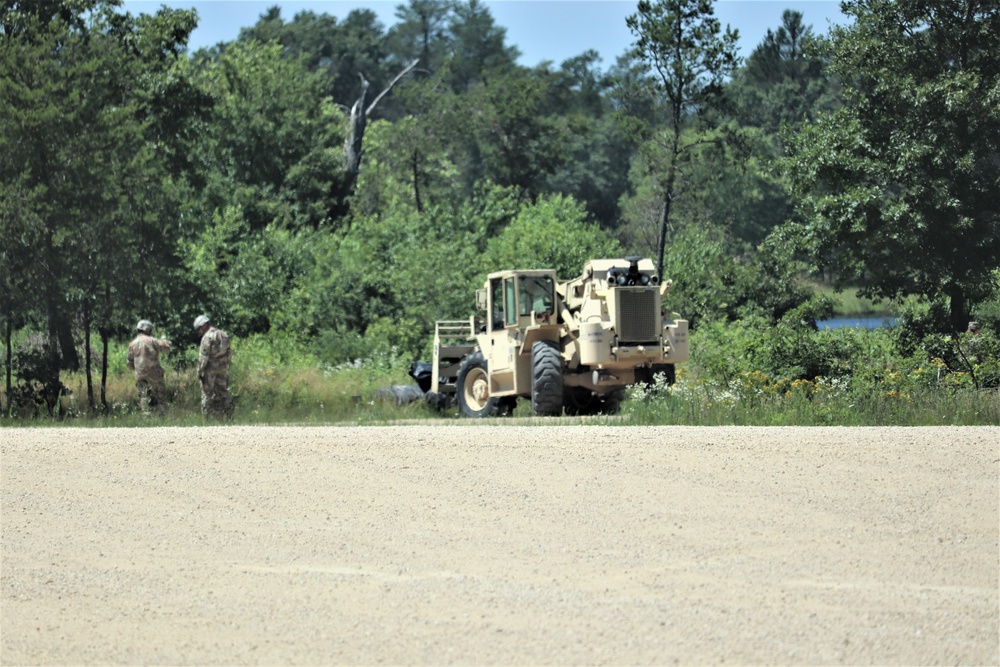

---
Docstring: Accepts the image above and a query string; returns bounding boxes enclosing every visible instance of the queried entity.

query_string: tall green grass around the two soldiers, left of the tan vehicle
[0,336,428,426]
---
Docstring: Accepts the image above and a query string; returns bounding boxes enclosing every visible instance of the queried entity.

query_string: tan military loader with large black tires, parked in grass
[428,257,688,417]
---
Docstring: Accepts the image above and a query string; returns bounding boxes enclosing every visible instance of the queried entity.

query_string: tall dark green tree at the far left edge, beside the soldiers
[0,0,201,409]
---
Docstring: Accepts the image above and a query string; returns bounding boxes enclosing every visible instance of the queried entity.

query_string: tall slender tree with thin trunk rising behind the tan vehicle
[627,0,739,274]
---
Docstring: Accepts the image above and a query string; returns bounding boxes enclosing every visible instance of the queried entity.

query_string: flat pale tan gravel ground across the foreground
[0,422,1000,665]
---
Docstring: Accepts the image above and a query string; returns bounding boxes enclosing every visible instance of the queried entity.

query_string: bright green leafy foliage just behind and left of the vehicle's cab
[289,186,519,361]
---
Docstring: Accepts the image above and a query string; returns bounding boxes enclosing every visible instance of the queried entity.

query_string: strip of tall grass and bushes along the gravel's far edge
[0,323,1000,426]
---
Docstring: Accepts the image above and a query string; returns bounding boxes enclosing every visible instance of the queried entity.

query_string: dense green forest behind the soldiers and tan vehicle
[0,0,1000,423]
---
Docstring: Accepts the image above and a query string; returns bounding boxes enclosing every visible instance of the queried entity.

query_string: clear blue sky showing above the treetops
[124,0,846,69]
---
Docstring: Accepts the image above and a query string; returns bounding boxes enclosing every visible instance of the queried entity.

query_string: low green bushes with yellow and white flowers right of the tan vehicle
[623,313,1000,425]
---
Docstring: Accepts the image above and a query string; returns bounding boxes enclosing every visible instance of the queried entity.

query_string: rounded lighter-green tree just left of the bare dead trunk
[195,41,349,231]
